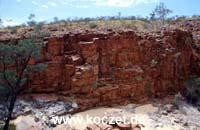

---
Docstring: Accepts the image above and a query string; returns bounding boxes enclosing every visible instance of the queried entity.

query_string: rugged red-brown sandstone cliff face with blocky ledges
[22,30,195,107]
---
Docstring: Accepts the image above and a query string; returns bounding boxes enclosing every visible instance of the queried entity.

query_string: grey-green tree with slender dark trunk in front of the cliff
[0,36,46,130]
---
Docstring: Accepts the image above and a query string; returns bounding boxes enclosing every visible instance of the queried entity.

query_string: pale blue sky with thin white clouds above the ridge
[0,0,200,26]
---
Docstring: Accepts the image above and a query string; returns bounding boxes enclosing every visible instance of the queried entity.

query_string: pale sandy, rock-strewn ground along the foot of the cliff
[1,101,200,130]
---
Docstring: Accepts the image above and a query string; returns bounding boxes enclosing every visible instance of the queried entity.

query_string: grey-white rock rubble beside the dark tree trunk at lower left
[0,100,78,128]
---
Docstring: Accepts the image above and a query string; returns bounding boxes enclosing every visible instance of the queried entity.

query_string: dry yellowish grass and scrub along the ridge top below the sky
[3,13,200,34]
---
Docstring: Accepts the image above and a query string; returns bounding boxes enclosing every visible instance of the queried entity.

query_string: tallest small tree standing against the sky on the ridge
[152,2,172,25]
